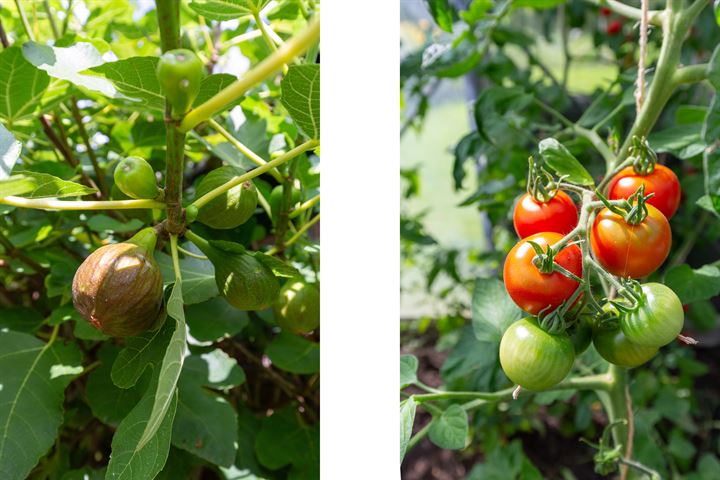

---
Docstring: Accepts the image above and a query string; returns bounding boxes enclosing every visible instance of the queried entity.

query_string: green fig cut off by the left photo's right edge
[273,279,320,333]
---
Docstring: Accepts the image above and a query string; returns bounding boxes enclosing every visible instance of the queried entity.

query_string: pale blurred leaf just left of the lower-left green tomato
[472,278,523,343]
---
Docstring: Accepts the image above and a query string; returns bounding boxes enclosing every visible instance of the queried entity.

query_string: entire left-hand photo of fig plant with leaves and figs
[0,0,320,480]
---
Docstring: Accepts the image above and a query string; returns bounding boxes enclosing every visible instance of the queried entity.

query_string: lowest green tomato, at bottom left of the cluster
[500,317,575,391]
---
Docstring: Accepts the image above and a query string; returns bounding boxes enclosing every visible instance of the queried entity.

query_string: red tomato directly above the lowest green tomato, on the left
[503,232,582,315]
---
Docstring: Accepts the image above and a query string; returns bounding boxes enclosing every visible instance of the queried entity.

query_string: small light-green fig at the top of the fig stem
[157,48,205,118]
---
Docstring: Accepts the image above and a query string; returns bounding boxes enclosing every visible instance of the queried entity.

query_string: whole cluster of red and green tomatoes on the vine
[500,159,684,391]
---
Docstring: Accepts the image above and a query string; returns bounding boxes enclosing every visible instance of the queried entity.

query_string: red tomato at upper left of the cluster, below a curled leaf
[513,190,578,238]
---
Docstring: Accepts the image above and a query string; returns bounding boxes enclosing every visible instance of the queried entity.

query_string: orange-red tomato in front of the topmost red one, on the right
[590,205,672,278]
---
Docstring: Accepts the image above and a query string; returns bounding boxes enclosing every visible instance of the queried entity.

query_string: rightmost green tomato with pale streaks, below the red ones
[620,283,685,347]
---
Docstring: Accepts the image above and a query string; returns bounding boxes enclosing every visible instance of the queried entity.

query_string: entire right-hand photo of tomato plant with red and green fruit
[400,0,720,480]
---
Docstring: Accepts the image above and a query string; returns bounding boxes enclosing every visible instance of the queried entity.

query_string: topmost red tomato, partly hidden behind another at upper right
[608,165,680,219]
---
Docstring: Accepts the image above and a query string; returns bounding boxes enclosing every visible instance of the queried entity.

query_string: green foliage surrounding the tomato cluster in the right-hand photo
[400,0,720,478]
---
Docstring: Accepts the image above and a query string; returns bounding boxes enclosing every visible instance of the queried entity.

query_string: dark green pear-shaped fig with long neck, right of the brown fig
[185,231,280,310]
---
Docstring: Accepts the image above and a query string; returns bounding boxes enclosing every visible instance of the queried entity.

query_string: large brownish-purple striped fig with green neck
[72,227,165,337]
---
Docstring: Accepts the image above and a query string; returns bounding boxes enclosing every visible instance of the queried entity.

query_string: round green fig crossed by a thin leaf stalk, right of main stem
[195,166,258,229]
